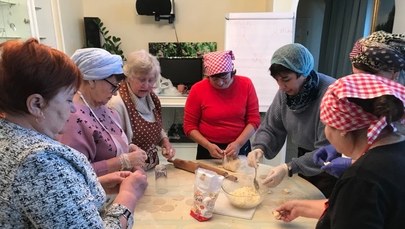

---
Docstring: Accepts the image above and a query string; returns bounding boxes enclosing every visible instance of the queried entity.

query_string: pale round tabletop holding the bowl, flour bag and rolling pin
[133,160,324,229]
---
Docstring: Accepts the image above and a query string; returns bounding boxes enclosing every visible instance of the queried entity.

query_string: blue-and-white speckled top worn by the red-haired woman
[0,119,129,228]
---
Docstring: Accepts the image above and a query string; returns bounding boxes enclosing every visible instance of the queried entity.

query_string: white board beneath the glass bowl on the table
[214,190,256,219]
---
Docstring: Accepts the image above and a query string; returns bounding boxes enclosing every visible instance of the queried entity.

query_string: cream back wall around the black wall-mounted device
[82,0,269,55]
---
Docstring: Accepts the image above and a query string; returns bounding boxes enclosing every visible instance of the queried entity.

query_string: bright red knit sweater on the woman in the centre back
[183,76,260,143]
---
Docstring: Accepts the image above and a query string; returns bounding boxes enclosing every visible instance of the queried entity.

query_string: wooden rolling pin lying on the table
[168,159,238,181]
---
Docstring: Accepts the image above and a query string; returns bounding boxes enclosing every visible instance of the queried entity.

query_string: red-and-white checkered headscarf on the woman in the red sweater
[203,51,235,76]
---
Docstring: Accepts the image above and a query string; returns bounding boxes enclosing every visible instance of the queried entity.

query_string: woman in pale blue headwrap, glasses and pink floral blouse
[59,48,146,176]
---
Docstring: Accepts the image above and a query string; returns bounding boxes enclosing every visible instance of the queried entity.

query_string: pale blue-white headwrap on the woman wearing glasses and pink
[72,48,123,80]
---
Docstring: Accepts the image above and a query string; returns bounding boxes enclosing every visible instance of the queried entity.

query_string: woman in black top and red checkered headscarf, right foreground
[276,74,405,229]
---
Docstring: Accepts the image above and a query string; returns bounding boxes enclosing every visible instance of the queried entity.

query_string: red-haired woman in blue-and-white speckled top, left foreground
[0,39,147,228]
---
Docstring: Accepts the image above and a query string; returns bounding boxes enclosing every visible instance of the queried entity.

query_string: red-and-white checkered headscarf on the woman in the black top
[320,74,405,145]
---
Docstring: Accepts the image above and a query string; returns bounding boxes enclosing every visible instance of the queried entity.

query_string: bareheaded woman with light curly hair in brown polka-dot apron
[108,50,175,170]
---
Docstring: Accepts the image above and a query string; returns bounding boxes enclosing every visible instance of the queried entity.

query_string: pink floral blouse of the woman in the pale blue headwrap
[58,103,129,176]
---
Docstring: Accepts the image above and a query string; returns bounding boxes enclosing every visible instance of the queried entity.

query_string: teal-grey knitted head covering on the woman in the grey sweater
[270,43,314,77]
